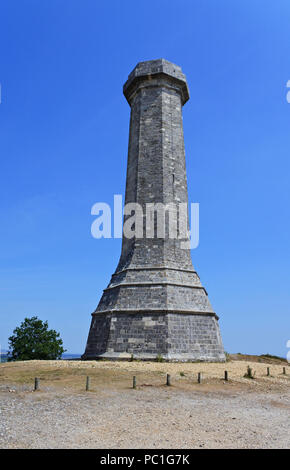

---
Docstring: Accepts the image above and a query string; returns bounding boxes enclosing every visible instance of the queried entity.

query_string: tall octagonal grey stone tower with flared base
[83,59,225,361]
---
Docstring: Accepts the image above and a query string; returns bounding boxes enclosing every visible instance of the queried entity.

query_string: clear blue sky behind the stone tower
[0,0,290,356]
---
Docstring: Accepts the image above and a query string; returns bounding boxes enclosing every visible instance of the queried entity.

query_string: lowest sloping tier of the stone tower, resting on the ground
[82,311,225,362]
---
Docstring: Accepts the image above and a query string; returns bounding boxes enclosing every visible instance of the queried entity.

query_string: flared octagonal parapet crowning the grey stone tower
[123,59,189,105]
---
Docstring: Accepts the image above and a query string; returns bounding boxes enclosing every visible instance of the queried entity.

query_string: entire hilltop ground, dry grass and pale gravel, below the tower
[0,355,290,449]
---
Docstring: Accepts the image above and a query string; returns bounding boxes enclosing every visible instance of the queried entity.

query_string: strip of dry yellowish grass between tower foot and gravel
[0,357,290,392]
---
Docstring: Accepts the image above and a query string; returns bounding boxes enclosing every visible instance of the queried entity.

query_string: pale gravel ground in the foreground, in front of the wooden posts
[0,385,290,449]
